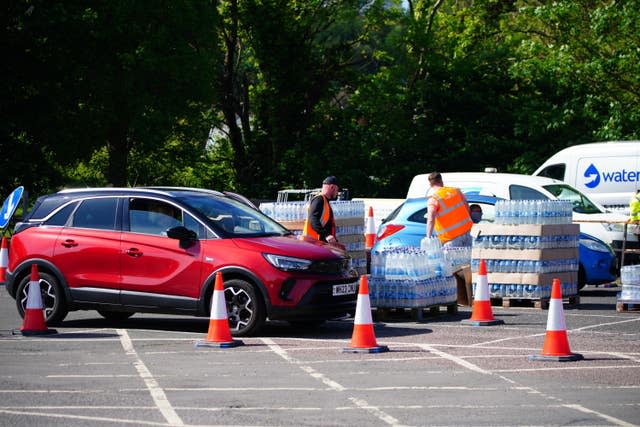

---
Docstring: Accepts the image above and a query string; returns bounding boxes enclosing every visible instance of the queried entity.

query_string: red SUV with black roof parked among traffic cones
[5,188,358,336]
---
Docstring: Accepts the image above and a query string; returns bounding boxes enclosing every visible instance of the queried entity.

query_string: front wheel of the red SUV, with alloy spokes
[224,279,266,337]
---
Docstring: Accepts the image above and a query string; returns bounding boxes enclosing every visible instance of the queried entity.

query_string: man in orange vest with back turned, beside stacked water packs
[427,172,473,247]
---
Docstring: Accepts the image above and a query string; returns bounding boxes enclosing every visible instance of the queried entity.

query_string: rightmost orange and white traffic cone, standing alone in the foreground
[529,279,583,362]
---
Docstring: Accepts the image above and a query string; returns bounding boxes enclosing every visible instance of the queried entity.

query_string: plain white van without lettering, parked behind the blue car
[407,172,638,253]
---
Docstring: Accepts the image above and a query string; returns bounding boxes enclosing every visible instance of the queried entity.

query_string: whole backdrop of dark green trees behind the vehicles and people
[0,0,640,202]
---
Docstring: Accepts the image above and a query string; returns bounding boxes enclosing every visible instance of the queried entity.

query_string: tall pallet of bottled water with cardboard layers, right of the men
[471,204,580,306]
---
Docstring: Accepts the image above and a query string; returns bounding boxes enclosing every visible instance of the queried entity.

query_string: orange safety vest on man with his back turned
[431,187,473,243]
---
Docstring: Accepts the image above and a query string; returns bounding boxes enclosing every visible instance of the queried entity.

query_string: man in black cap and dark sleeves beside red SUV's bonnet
[302,176,340,244]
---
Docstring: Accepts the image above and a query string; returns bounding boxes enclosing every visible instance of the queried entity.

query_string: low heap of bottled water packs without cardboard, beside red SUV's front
[369,239,457,308]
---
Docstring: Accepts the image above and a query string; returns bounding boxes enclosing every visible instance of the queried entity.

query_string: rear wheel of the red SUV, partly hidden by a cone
[16,272,69,325]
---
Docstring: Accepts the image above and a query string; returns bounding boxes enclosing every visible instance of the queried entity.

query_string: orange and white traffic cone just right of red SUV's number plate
[342,276,389,353]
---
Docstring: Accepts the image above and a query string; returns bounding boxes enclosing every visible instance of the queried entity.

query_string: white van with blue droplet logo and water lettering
[533,141,640,214]
